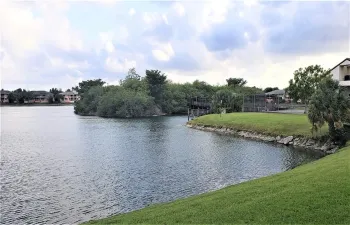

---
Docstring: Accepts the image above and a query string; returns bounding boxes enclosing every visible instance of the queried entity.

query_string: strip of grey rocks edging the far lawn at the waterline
[187,124,339,155]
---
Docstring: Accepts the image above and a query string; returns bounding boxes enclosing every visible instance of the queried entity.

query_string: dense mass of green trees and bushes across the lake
[74,68,263,117]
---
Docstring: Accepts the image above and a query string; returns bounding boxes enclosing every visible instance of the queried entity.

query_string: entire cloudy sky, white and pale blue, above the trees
[0,0,350,90]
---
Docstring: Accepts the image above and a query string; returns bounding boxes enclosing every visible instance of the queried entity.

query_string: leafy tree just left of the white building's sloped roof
[288,65,330,113]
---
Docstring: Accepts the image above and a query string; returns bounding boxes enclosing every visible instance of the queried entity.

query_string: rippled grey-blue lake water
[0,106,318,224]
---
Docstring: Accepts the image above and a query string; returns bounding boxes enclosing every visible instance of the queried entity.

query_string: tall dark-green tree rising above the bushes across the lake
[146,70,167,105]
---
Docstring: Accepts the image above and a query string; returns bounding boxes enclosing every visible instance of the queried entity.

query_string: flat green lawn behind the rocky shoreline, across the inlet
[190,113,328,137]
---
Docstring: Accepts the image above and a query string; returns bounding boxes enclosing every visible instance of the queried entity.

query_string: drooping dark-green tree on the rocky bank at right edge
[308,78,350,144]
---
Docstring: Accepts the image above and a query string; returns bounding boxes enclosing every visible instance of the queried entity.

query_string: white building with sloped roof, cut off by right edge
[330,58,350,96]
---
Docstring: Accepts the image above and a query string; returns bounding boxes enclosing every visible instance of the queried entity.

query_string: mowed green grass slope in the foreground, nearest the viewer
[85,146,350,224]
